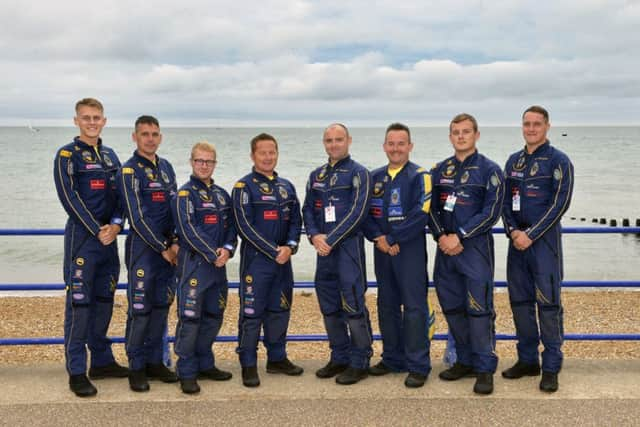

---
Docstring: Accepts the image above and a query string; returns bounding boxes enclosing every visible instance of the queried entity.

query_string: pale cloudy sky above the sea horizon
[0,0,640,126]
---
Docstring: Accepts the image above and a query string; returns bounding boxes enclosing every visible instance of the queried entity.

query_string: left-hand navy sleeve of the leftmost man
[53,148,100,236]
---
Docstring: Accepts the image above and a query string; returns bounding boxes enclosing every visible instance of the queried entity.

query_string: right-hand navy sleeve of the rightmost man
[525,157,573,241]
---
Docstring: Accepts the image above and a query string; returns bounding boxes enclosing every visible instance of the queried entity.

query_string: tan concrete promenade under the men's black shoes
[0,359,640,427]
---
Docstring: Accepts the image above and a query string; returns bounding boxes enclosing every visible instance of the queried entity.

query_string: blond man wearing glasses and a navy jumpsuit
[174,141,236,394]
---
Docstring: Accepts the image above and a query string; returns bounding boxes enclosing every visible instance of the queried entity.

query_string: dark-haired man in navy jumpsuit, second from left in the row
[118,116,178,391]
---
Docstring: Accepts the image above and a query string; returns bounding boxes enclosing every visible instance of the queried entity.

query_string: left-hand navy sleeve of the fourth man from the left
[231,181,278,259]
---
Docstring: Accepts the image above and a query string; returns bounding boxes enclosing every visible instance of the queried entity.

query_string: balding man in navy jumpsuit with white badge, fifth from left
[302,123,372,385]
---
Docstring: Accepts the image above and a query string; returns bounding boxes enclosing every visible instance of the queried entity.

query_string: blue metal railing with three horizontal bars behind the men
[0,227,640,345]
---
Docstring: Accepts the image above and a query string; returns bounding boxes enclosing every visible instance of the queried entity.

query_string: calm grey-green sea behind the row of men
[0,127,640,283]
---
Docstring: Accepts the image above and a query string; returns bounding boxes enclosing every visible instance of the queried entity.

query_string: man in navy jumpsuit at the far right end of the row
[502,106,573,392]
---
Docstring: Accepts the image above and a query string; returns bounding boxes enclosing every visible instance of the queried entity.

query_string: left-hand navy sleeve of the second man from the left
[118,167,171,252]
